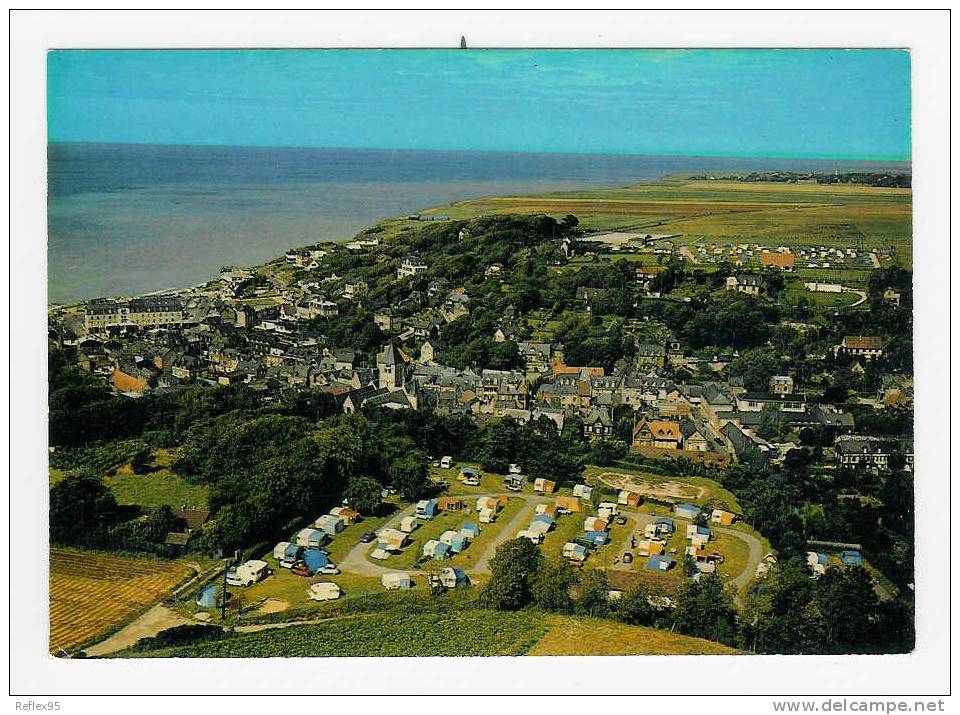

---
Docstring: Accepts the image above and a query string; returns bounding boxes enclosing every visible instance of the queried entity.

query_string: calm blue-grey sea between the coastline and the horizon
[47,143,909,304]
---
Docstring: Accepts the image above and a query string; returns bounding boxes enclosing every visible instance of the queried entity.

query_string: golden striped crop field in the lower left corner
[50,549,190,653]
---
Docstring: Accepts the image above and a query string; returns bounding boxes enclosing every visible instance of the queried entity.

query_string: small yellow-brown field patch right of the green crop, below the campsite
[527,616,737,655]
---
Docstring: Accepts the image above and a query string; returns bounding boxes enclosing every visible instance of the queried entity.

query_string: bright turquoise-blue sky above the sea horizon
[47,50,910,160]
